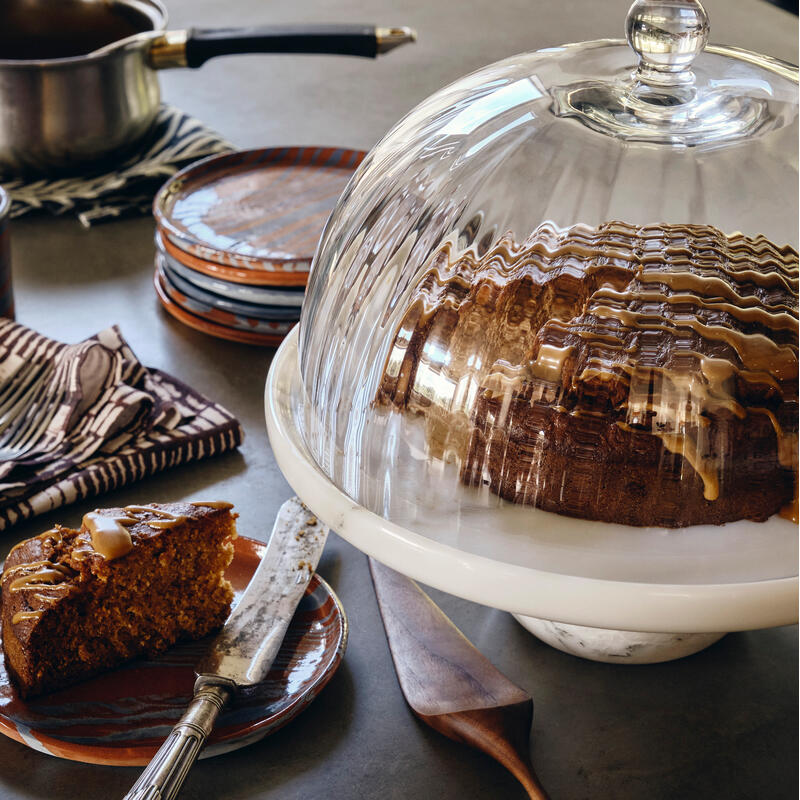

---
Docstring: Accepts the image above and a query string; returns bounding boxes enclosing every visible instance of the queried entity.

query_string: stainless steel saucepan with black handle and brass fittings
[0,0,416,174]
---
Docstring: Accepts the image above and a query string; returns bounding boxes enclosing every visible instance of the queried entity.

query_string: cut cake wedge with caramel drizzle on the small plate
[2,502,237,697]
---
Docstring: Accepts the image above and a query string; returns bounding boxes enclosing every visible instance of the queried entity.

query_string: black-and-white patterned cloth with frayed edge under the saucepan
[2,106,232,228]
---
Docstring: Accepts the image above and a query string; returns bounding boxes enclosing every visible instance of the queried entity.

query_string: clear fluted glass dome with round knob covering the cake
[299,2,798,564]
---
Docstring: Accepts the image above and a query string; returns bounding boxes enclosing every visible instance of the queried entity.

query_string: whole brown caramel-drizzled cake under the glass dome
[376,222,798,527]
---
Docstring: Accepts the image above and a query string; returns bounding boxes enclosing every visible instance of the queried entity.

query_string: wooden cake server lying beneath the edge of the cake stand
[369,558,547,800]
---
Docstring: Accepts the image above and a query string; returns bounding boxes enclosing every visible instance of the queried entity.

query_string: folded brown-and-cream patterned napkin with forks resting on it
[0,319,243,531]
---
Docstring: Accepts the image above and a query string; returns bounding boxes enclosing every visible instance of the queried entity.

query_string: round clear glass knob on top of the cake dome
[625,0,709,84]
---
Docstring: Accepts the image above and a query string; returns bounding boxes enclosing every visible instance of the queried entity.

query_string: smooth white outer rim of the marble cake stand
[264,326,798,633]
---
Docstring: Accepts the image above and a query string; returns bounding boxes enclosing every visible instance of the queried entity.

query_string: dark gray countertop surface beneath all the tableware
[0,0,798,800]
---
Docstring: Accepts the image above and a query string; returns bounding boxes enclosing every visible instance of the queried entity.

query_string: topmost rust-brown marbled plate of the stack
[153,147,365,283]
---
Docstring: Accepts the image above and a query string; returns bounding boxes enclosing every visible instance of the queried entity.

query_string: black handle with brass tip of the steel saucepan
[179,25,416,67]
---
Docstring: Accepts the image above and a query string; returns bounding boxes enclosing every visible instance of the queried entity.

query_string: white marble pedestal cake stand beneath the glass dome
[265,328,798,663]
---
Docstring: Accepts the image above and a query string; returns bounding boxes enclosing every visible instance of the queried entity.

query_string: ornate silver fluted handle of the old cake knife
[124,684,231,800]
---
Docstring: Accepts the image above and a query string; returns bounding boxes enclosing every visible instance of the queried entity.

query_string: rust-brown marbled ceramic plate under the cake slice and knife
[0,537,347,766]
